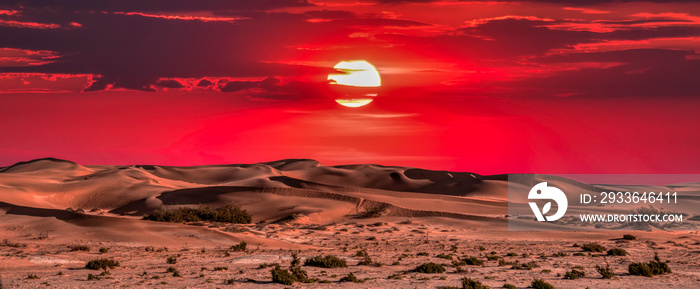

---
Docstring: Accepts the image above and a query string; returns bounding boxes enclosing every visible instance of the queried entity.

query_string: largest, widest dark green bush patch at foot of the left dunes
[143,204,253,224]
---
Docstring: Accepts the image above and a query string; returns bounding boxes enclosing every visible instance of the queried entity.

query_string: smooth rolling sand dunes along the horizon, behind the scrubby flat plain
[0,158,698,246]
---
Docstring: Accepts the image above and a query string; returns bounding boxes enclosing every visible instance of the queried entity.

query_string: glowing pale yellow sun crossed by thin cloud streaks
[328,60,382,107]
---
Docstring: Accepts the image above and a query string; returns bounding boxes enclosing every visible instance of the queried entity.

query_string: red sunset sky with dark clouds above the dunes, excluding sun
[0,0,700,174]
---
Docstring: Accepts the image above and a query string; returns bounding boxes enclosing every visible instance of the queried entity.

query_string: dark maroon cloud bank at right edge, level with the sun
[509,49,700,97]
